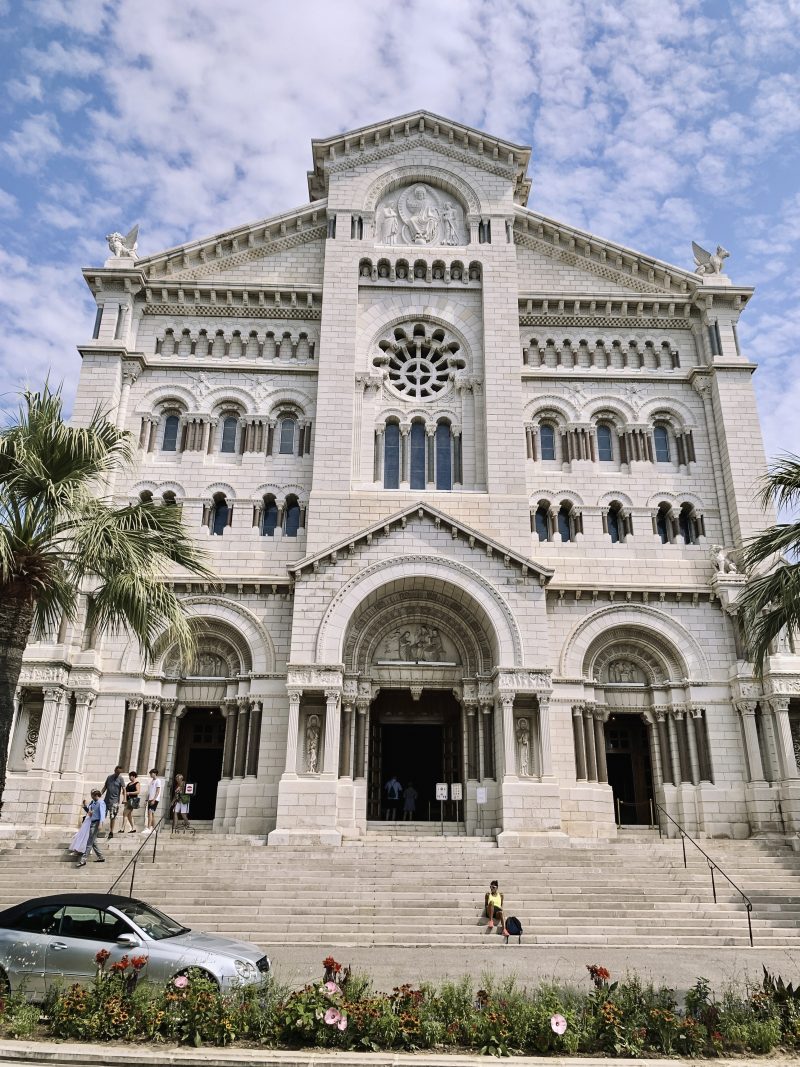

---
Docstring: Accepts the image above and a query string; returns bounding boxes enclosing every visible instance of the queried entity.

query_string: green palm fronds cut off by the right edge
[738,455,800,676]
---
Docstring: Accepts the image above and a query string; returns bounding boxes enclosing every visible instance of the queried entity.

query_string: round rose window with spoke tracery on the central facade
[374,322,464,400]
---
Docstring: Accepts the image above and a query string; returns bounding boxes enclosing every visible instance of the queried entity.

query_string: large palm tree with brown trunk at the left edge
[0,384,213,810]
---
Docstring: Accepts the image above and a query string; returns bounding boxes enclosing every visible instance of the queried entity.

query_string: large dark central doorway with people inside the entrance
[367,689,463,822]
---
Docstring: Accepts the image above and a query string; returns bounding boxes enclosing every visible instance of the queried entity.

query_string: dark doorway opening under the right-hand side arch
[605,715,653,826]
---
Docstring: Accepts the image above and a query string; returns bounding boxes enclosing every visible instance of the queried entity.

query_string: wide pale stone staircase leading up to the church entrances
[0,824,800,950]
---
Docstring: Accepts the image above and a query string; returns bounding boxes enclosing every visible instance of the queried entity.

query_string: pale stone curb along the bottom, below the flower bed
[0,1041,780,1067]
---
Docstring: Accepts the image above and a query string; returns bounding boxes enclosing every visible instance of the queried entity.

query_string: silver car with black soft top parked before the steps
[0,893,271,1000]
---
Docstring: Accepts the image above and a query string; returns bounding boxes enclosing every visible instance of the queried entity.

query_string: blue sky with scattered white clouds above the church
[0,0,800,456]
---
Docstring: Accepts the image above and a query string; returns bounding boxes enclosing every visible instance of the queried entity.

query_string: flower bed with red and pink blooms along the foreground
[0,952,800,1056]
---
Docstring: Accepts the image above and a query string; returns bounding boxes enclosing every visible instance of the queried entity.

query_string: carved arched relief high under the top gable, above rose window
[375,181,467,244]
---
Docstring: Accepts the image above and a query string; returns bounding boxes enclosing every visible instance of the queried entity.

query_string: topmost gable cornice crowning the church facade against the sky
[308,111,530,204]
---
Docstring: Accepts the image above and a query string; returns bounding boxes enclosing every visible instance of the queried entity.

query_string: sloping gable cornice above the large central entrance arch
[288,500,555,585]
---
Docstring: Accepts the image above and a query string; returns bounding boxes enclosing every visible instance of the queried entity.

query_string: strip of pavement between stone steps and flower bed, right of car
[264,947,800,992]
